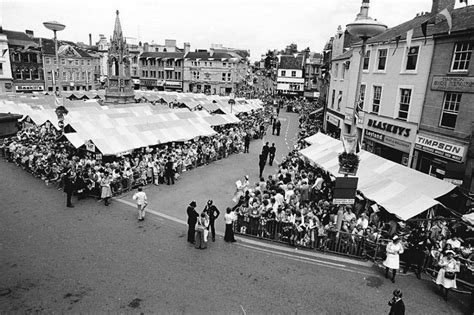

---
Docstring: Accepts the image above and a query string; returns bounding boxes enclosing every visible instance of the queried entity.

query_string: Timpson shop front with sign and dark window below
[413,133,468,186]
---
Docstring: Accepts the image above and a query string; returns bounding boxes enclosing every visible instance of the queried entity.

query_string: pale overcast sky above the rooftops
[0,0,466,60]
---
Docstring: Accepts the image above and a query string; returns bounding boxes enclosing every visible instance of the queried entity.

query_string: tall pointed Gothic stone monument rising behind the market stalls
[105,10,135,104]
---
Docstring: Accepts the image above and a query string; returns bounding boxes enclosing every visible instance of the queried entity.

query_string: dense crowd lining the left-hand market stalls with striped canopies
[0,110,271,207]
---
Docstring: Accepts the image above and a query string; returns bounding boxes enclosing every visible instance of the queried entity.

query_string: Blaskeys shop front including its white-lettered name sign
[363,115,417,166]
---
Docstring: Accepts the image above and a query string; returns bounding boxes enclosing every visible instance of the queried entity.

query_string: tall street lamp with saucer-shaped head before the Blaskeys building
[346,0,387,135]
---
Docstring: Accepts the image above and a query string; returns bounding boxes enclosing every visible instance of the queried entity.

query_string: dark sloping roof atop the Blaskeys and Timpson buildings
[367,6,474,44]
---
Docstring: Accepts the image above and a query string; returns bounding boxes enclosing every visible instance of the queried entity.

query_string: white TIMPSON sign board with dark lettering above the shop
[415,135,465,162]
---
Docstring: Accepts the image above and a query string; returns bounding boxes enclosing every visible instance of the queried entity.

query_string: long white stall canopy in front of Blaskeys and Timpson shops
[300,133,456,220]
